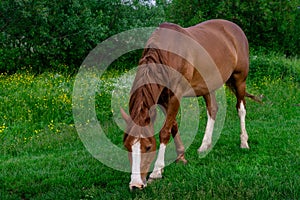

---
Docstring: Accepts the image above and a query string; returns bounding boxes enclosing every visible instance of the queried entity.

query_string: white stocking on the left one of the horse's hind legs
[198,112,215,152]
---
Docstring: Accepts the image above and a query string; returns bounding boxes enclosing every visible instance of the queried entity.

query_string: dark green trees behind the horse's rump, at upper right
[166,0,300,56]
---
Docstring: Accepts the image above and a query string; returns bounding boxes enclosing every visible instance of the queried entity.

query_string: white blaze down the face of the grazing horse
[129,141,145,189]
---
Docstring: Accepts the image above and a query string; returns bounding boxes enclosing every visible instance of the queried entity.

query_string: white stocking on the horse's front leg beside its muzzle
[149,143,166,179]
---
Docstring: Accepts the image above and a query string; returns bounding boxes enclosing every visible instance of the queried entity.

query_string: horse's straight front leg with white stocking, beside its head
[149,96,181,181]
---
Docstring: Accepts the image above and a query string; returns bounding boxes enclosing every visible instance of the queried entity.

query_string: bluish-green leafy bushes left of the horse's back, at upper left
[0,0,162,72]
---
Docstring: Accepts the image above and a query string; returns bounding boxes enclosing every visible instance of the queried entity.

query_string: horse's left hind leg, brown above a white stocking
[198,93,218,152]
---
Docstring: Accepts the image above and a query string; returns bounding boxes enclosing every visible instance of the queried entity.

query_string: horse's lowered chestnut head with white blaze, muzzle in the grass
[121,109,156,190]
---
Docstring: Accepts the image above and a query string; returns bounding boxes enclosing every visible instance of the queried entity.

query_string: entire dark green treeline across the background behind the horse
[0,0,300,72]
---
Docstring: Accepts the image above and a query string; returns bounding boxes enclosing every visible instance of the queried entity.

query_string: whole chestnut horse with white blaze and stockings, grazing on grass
[121,20,257,189]
